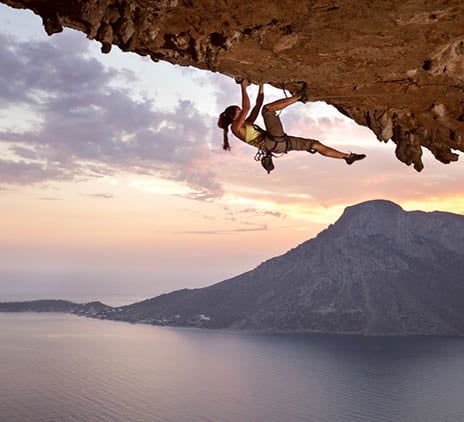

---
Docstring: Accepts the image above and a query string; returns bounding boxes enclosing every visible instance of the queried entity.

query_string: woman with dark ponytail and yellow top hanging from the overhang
[218,80,366,164]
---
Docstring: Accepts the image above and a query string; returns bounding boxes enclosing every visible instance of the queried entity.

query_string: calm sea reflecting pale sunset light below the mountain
[0,314,464,422]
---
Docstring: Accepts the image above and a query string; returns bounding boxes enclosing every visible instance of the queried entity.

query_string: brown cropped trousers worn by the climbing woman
[261,108,319,153]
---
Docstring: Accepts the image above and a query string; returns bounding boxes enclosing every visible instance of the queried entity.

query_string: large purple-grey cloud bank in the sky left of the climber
[0,31,222,200]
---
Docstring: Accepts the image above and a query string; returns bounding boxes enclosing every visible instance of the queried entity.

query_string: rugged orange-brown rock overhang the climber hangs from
[1,0,464,171]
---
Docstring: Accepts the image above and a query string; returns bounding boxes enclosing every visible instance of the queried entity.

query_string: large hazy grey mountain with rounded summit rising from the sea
[106,200,464,335]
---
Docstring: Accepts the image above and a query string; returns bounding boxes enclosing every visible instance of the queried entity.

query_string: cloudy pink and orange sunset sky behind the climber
[0,5,464,305]
